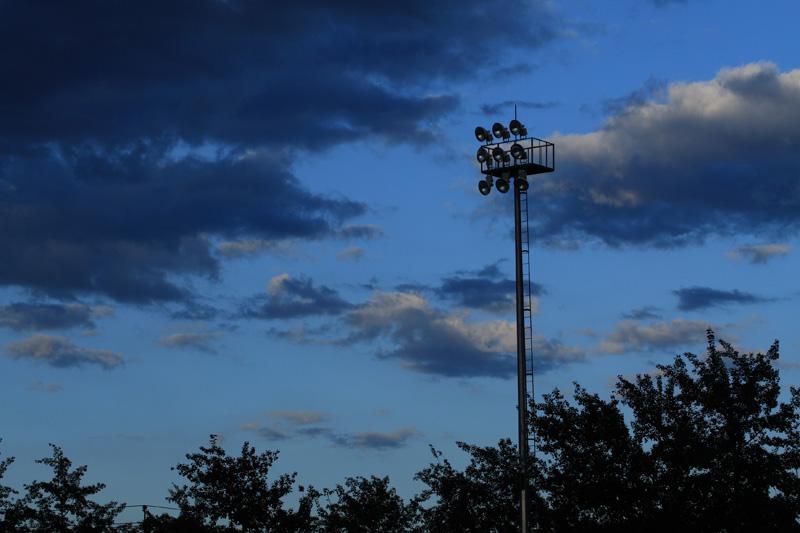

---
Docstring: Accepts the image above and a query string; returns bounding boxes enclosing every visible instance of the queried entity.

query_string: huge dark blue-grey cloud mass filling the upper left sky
[0,0,554,303]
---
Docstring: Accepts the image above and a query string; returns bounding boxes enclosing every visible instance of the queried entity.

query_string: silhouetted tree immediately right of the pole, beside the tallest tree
[531,383,652,531]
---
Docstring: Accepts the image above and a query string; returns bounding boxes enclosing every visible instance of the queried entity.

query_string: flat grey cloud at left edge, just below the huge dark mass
[0,302,107,331]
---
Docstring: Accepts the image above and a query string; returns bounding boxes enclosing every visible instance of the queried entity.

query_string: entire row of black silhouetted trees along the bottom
[0,330,800,533]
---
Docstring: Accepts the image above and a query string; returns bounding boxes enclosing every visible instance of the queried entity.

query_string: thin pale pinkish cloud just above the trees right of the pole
[598,318,718,354]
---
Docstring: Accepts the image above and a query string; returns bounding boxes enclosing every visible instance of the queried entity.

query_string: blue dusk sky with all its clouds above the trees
[0,0,800,519]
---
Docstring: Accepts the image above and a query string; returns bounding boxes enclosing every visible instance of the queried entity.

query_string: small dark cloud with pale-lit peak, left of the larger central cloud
[239,273,352,319]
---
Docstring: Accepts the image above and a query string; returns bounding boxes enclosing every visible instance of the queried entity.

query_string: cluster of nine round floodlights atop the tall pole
[475,119,528,196]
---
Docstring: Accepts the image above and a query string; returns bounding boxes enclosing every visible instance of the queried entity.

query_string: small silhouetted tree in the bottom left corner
[6,444,125,533]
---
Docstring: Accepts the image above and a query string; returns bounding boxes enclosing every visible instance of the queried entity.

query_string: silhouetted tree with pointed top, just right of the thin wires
[167,435,318,533]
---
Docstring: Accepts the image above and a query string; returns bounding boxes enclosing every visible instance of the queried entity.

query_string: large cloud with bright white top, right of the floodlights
[528,63,800,247]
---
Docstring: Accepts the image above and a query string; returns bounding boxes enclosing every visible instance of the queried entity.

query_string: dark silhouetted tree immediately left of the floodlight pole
[414,439,519,533]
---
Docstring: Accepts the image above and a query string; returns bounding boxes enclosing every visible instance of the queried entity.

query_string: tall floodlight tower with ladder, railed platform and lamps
[475,118,555,533]
